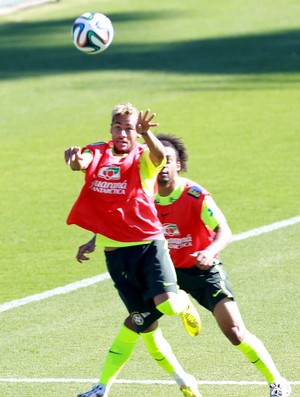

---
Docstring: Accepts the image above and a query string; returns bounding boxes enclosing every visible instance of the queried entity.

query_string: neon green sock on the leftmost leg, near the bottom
[100,325,139,388]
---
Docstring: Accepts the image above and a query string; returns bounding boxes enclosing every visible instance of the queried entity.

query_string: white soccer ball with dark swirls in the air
[72,12,114,54]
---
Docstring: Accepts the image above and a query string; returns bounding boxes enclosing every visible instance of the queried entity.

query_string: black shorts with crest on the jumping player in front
[105,240,178,332]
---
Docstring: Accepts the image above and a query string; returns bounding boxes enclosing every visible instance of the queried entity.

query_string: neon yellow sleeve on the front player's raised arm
[139,148,166,196]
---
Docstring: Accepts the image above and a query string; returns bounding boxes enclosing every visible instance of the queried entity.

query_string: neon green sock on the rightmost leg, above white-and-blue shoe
[236,332,280,383]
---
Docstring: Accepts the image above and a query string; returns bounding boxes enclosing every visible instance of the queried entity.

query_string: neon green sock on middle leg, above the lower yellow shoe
[140,327,186,377]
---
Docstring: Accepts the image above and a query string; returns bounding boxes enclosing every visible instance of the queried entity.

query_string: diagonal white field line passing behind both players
[0,215,300,312]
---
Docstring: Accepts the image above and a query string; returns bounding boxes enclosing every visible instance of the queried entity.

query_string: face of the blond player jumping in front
[110,114,139,153]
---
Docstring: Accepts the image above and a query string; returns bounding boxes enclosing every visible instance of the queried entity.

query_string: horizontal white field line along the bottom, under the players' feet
[0,378,300,386]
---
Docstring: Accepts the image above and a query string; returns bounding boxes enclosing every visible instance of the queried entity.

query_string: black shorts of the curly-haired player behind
[176,263,234,312]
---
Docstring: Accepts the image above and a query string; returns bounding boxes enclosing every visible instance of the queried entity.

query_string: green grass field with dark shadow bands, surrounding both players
[0,0,300,397]
